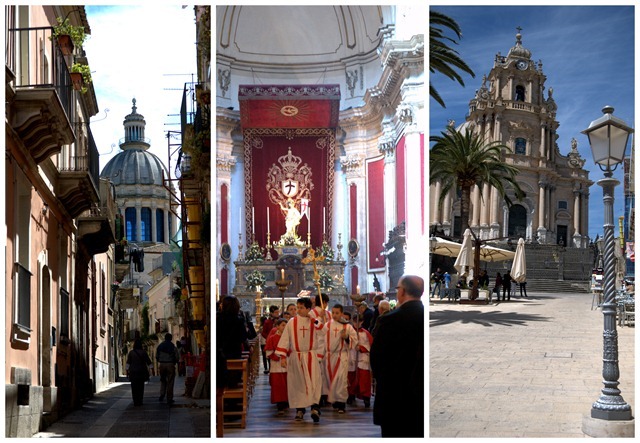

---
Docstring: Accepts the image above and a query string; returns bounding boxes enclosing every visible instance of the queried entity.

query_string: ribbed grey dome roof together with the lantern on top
[100,98,169,186]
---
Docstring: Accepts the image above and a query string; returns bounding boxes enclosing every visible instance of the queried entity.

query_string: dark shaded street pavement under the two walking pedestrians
[34,376,211,438]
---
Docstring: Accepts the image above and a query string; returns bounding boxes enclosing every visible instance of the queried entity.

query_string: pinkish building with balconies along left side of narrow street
[5,5,115,437]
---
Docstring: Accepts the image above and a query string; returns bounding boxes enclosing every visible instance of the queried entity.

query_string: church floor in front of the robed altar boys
[224,373,380,438]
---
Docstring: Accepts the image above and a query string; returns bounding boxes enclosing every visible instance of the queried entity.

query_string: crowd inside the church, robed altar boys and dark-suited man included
[216,275,424,437]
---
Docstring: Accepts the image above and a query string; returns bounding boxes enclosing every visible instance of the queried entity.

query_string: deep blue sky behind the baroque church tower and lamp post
[429,5,635,243]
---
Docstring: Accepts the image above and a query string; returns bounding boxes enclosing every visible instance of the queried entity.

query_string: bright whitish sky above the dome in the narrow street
[84,3,196,175]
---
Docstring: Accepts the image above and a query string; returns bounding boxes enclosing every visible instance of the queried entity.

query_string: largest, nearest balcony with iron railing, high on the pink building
[5,27,76,163]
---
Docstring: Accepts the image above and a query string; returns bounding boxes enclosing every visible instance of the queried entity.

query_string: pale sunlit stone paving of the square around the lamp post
[428,292,636,437]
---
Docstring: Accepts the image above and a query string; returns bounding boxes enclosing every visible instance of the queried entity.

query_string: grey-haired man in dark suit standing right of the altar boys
[371,275,424,438]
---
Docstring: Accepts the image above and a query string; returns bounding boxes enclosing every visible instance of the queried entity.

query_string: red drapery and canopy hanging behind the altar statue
[238,84,340,247]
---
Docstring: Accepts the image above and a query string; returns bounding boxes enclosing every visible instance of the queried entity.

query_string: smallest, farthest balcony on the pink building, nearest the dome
[78,179,116,255]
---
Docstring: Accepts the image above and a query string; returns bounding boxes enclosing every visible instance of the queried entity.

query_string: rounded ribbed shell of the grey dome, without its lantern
[100,149,168,186]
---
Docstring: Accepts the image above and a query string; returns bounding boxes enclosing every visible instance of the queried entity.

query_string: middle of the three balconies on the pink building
[56,124,100,220]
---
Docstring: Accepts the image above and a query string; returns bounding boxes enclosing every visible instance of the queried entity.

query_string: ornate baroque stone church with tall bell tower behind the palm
[430,33,593,248]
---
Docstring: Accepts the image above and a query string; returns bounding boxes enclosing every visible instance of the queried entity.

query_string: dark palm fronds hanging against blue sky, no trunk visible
[429,11,476,108]
